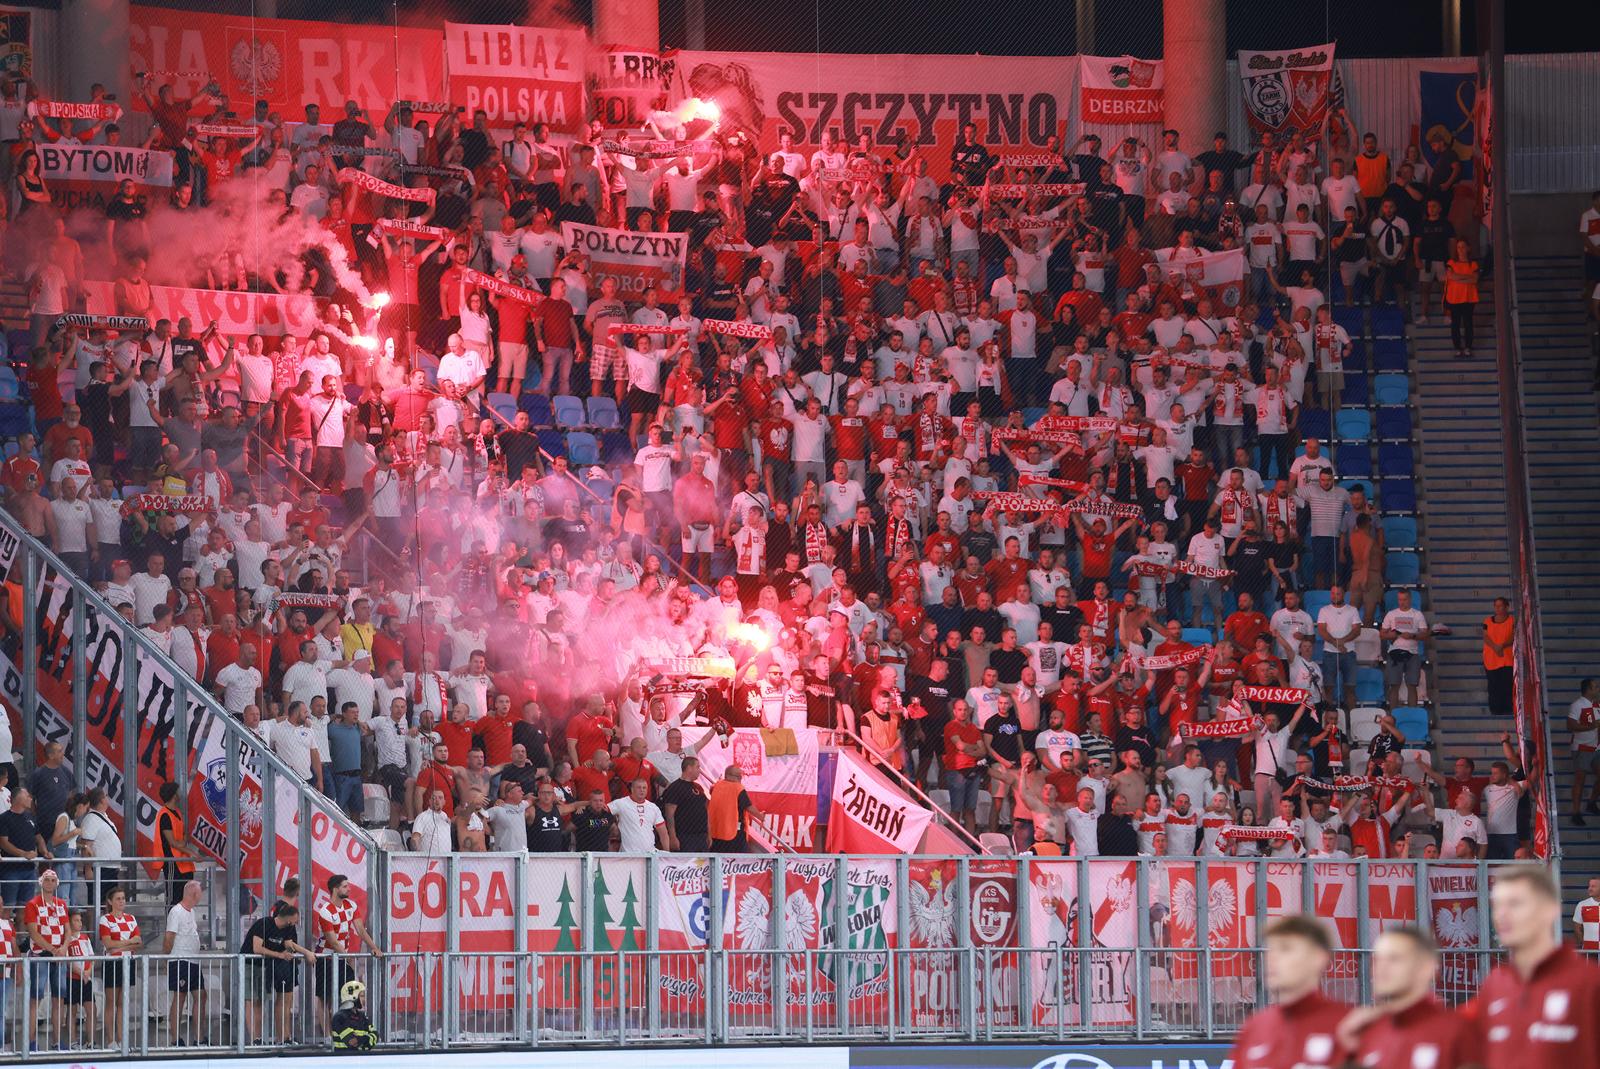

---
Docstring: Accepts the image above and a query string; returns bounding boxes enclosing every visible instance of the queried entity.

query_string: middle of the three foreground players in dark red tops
[1339,927,1483,1069]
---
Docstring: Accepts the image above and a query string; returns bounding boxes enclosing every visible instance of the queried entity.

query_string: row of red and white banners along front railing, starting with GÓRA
[382,855,1494,1027]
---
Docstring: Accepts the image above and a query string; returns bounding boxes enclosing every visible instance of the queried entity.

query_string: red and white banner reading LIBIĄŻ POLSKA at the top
[445,22,586,133]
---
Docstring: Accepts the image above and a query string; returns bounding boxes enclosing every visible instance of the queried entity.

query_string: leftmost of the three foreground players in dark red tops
[1229,915,1350,1069]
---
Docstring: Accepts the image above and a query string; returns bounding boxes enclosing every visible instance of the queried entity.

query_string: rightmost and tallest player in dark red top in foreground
[1462,864,1600,1069]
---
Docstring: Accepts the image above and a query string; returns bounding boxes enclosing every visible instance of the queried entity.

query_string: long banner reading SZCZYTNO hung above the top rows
[672,51,1078,178]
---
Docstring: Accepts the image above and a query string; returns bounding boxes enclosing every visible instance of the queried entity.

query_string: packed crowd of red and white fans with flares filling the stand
[0,62,1538,870]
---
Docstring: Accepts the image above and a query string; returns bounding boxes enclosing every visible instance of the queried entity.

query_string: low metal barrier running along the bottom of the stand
[0,946,1498,1061]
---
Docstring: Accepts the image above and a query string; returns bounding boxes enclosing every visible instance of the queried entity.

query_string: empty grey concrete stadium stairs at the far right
[1515,253,1600,901]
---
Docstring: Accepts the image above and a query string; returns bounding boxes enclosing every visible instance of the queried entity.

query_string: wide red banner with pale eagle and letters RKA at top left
[128,5,445,116]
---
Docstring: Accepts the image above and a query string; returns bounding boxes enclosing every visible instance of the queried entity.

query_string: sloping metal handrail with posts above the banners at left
[0,507,379,903]
